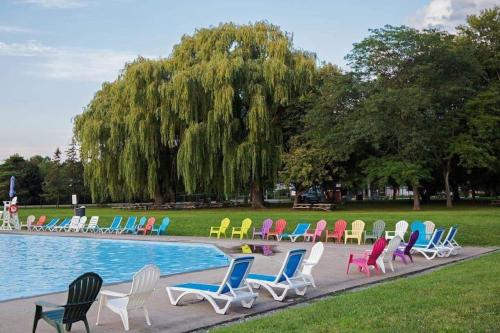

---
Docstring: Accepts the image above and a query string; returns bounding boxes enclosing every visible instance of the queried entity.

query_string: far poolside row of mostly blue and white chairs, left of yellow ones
[22,215,170,235]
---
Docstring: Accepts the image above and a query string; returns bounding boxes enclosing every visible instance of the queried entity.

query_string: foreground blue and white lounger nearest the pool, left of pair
[166,257,258,314]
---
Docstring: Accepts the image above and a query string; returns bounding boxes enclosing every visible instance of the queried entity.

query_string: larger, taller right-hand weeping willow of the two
[168,22,316,208]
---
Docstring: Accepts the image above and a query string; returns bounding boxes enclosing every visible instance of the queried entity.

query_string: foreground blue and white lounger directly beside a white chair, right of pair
[247,249,312,302]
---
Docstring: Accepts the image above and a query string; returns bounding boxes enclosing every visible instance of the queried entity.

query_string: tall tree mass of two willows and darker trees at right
[70,7,500,209]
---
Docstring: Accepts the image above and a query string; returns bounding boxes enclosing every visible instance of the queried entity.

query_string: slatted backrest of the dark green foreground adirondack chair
[63,272,102,324]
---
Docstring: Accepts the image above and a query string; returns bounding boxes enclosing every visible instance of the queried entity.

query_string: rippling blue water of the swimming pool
[0,234,229,301]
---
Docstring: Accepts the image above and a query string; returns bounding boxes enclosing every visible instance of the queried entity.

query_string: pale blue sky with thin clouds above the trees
[0,0,500,161]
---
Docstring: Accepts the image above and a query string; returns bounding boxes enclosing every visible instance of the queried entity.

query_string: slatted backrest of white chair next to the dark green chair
[127,265,160,309]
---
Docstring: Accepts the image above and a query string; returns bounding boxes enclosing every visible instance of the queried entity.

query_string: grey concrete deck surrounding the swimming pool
[0,232,497,333]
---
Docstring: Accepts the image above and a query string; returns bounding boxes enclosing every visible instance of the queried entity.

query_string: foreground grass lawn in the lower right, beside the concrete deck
[215,252,500,333]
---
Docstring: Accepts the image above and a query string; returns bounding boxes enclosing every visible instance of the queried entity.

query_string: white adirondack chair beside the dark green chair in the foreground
[96,265,160,331]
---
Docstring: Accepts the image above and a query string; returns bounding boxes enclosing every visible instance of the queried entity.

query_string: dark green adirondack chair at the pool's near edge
[33,273,102,333]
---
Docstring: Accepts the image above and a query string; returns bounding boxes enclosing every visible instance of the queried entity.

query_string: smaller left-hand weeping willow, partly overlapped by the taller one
[74,58,182,204]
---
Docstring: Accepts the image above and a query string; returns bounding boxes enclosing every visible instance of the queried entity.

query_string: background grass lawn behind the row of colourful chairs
[20,204,500,246]
